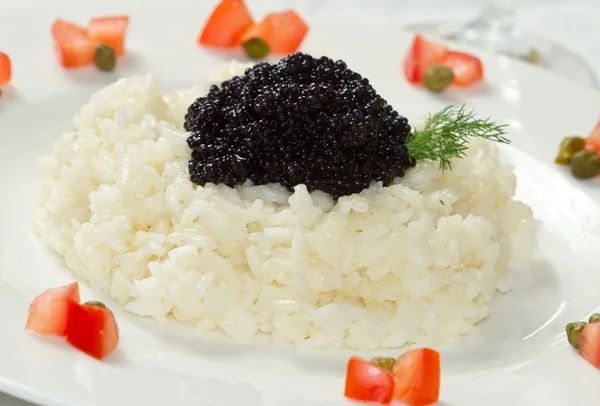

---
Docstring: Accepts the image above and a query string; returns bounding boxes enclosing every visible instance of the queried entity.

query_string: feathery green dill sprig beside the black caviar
[405,105,510,171]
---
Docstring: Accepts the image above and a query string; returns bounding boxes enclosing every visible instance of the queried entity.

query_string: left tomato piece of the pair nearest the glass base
[404,34,448,84]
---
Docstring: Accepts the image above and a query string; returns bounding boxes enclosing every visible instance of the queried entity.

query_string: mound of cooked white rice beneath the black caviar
[36,69,538,350]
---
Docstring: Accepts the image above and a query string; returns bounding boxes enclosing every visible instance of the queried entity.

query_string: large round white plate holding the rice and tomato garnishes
[0,0,600,406]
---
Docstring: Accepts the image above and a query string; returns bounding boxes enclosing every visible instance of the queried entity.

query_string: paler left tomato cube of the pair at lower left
[25,282,79,337]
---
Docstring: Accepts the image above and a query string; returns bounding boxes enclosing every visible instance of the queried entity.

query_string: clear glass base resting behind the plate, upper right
[407,20,598,87]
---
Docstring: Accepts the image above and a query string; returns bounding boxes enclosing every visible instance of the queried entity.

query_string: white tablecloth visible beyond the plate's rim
[0,0,600,406]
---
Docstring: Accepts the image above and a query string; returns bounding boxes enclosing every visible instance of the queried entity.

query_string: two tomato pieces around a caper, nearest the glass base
[404,34,483,91]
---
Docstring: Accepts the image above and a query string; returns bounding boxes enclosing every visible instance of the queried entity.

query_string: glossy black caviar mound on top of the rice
[184,53,415,199]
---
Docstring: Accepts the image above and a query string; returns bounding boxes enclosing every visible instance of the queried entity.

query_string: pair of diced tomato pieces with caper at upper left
[52,16,129,70]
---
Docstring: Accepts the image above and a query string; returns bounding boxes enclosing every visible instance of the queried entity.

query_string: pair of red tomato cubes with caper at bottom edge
[344,348,441,405]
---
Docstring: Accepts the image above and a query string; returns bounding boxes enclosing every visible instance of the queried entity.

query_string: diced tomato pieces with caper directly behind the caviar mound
[198,0,308,59]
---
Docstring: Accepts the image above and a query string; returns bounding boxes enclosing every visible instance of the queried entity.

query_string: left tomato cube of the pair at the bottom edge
[344,357,394,405]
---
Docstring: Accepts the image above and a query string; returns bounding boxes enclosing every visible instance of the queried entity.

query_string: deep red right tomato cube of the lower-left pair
[67,304,119,360]
